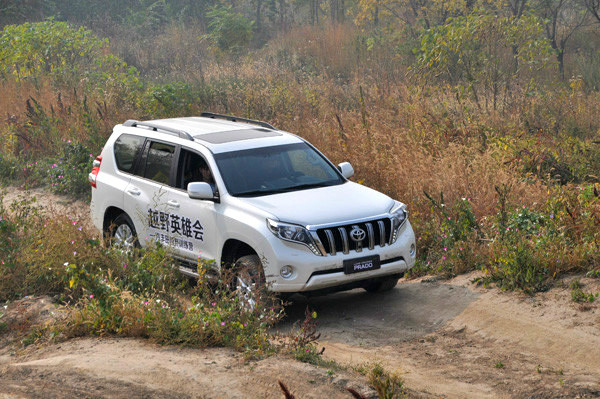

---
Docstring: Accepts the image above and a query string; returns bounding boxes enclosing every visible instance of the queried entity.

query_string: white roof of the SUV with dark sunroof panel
[122,117,303,154]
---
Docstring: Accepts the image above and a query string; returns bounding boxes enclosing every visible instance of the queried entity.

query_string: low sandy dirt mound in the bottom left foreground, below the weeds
[0,338,374,399]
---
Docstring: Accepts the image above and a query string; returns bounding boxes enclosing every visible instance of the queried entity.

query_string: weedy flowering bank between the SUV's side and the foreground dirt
[0,196,282,357]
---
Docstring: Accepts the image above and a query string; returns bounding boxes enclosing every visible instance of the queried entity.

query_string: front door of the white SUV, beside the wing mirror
[168,147,220,262]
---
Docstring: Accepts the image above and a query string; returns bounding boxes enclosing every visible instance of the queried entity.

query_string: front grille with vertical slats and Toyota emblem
[317,218,392,255]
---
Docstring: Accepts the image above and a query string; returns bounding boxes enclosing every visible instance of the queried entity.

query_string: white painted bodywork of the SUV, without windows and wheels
[90,114,416,293]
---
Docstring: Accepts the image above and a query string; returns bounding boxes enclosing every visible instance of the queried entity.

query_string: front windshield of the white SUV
[215,143,344,197]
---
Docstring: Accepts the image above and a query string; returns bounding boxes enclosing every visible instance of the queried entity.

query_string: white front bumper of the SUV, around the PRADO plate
[262,220,415,293]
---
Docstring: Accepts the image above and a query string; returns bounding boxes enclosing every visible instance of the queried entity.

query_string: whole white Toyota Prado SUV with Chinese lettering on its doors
[89,113,416,293]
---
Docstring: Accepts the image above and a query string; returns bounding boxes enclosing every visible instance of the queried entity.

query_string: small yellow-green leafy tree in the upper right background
[417,13,551,109]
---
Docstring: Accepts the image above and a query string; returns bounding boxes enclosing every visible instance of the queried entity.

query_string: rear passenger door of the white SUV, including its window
[124,139,177,246]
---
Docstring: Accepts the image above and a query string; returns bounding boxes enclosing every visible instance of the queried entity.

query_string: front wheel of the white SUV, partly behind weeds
[232,255,266,310]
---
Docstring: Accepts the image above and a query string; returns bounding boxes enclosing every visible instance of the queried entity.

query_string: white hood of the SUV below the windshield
[240,182,394,226]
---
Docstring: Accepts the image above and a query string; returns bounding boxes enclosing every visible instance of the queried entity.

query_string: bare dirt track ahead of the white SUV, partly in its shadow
[288,276,600,398]
